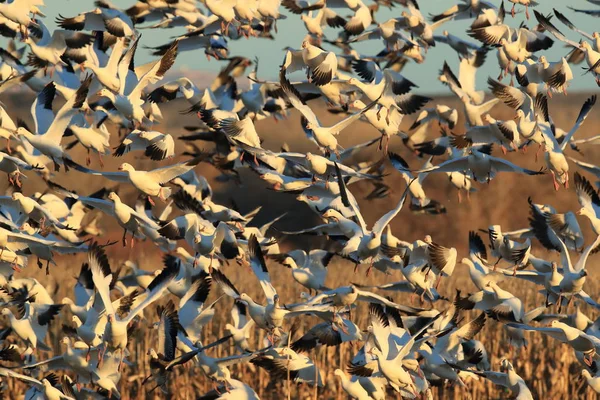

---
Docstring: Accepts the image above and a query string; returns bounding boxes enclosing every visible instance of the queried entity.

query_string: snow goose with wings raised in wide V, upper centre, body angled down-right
[279,69,376,156]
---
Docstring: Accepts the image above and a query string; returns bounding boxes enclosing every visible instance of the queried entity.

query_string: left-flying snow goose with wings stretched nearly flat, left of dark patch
[68,158,201,205]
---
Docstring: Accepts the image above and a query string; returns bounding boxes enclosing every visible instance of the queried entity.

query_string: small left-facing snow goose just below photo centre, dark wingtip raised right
[267,249,335,293]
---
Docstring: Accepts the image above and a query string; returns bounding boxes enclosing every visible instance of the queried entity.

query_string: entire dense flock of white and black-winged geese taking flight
[0,0,600,400]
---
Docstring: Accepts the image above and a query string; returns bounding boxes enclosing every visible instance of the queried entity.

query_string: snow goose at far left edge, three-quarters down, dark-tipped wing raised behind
[2,301,63,351]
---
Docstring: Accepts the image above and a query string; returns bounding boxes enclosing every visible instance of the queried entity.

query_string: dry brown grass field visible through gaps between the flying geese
[2,89,600,400]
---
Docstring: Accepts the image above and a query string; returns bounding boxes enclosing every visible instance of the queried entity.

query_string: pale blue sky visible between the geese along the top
[29,0,600,93]
